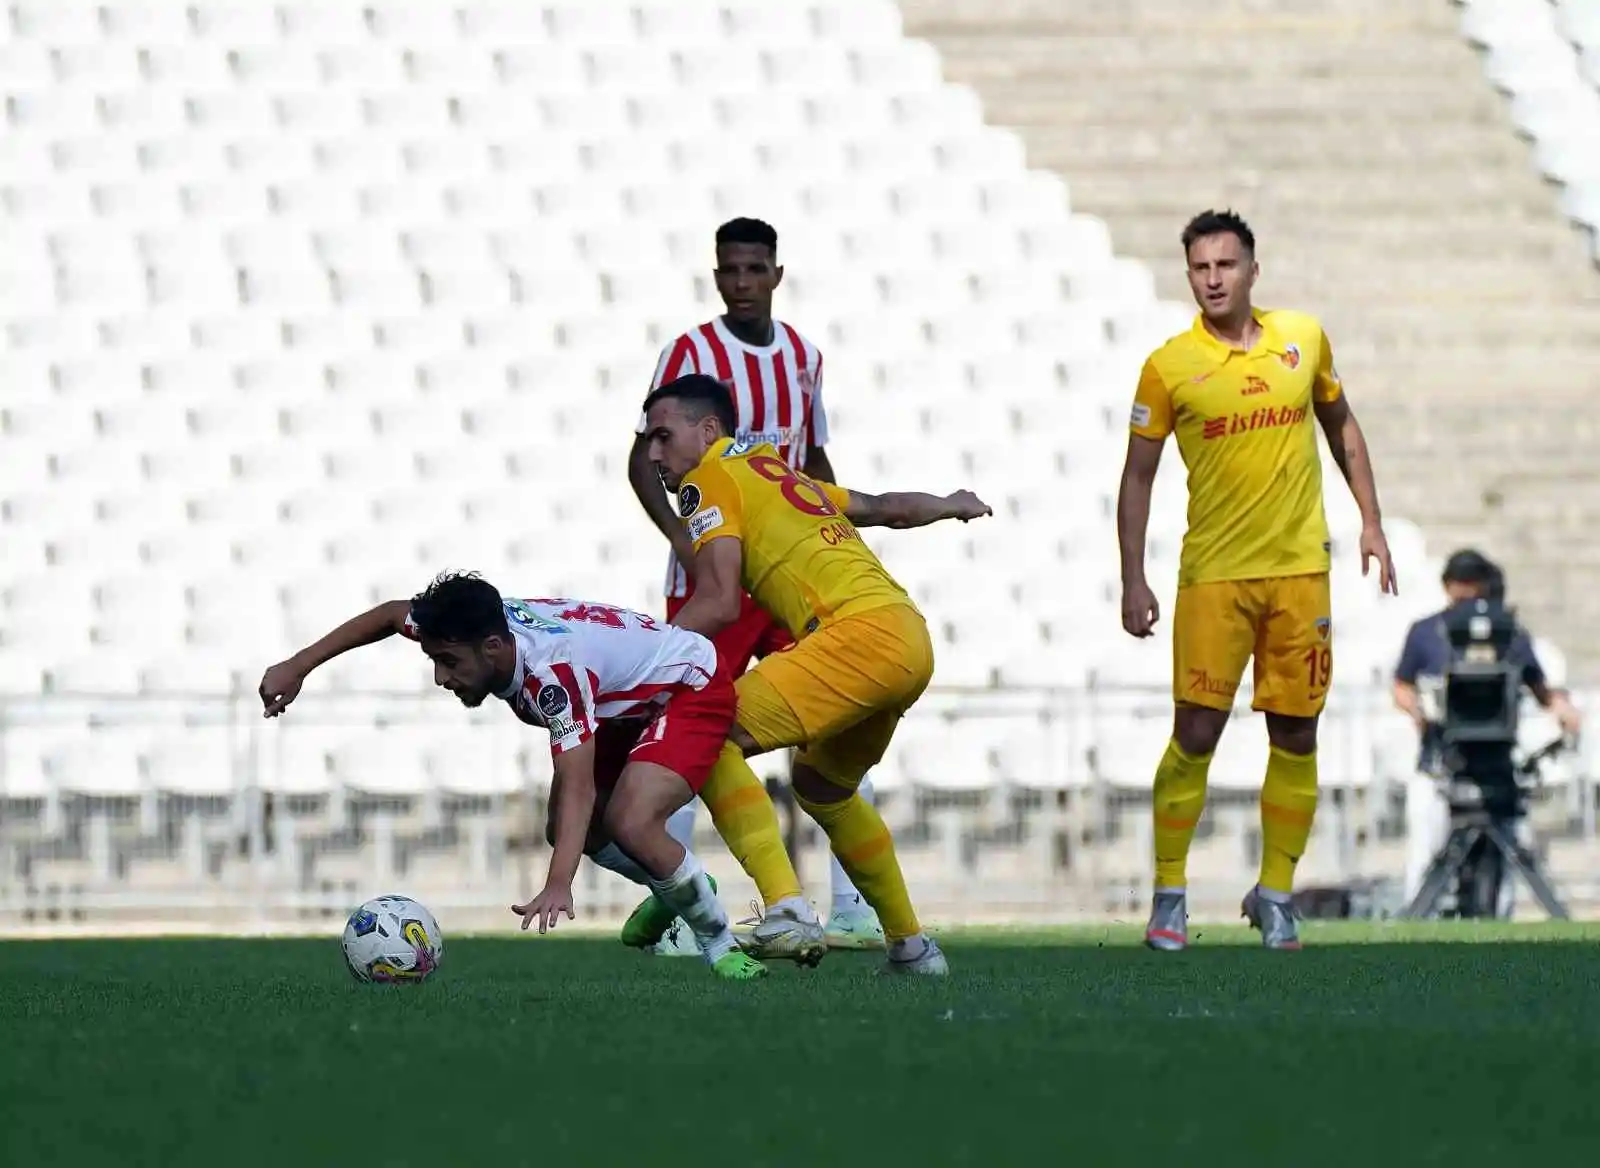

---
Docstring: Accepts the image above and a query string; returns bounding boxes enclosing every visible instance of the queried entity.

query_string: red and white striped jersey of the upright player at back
[635,317,827,597]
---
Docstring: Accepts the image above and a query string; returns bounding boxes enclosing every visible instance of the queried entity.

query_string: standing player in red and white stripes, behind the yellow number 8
[627,219,883,952]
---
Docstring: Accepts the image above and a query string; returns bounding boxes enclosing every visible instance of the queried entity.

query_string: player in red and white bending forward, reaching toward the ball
[261,574,824,979]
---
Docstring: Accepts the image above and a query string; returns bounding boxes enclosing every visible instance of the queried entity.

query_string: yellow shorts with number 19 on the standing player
[1173,573,1333,718]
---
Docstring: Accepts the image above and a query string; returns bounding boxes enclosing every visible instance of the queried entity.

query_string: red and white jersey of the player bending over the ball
[405,600,717,754]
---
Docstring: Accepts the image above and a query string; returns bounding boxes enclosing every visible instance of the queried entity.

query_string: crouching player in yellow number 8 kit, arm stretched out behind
[645,374,992,974]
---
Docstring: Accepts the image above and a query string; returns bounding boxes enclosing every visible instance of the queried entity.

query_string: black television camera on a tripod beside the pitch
[1400,601,1568,920]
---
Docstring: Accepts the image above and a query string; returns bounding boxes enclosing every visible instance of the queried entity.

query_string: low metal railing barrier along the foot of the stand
[0,683,1600,931]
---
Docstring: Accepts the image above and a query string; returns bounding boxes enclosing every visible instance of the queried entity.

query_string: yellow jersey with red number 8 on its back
[678,438,915,640]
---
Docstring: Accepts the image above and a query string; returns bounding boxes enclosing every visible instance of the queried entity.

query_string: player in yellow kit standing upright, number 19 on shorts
[1117,211,1395,950]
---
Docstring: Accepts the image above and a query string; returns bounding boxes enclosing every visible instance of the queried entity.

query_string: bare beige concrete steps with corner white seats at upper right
[902,0,1600,678]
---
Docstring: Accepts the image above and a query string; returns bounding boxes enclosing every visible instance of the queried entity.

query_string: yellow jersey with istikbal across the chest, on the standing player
[1131,310,1342,586]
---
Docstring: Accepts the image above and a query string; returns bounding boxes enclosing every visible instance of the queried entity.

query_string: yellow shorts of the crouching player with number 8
[734,605,933,787]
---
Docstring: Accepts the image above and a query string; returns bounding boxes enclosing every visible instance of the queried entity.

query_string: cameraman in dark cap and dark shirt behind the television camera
[1395,549,1581,902]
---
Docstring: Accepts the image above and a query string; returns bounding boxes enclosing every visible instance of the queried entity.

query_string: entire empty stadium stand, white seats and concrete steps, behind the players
[0,0,1600,920]
